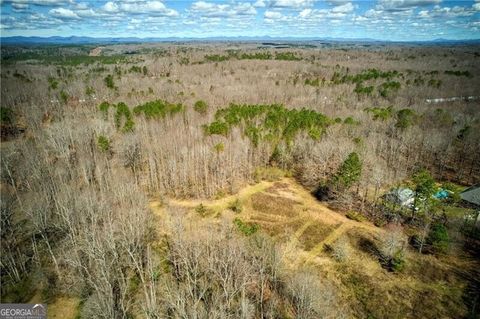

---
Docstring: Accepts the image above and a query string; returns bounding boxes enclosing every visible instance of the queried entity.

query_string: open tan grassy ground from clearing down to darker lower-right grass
[151,178,466,318]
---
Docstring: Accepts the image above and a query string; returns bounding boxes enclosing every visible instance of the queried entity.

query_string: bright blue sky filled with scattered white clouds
[0,0,480,41]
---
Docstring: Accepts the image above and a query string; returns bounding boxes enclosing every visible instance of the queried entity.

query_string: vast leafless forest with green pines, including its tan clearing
[1,42,480,318]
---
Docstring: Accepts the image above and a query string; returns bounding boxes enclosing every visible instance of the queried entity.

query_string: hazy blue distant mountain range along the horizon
[0,36,480,44]
